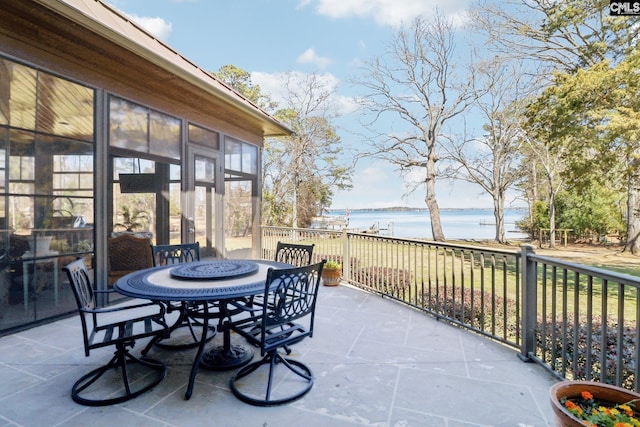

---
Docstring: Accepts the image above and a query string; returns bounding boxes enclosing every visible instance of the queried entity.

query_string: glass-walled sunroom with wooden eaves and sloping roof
[0,0,290,334]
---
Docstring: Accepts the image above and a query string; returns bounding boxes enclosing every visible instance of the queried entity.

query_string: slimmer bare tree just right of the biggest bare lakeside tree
[444,57,532,243]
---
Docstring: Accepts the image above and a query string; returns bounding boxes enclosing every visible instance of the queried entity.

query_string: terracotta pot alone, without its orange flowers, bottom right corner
[549,381,640,427]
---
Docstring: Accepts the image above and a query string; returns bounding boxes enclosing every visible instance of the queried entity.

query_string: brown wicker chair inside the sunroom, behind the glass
[107,234,153,286]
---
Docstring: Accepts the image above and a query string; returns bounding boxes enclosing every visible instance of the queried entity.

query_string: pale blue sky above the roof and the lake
[106,0,510,209]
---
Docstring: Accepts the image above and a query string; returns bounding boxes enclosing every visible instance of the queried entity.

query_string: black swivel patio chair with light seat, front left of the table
[62,258,169,406]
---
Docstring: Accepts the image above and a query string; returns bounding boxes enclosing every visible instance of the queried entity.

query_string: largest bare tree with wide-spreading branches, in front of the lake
[357,13,475,241]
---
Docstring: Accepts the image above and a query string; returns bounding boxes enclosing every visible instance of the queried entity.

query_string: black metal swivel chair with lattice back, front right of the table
[229,261,325,406]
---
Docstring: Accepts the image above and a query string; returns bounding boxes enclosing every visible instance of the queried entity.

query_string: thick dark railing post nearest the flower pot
[518,245,538,362]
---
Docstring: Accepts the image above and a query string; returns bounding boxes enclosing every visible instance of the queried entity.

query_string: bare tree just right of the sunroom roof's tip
[265,73,353,227]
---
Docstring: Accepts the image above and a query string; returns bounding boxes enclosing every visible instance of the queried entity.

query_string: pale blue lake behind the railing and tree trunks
[328,209,527,240]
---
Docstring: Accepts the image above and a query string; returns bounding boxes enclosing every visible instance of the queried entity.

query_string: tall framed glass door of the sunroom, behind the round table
[184,146,223,258]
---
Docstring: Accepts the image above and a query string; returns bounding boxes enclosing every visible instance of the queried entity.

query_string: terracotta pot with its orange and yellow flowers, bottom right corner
[550,381,640,427]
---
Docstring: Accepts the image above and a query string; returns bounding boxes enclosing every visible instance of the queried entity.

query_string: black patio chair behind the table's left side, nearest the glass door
[151,242,216,350]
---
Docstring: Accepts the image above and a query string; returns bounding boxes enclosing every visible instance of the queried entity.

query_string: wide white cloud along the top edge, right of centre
[298,0,469,27]
